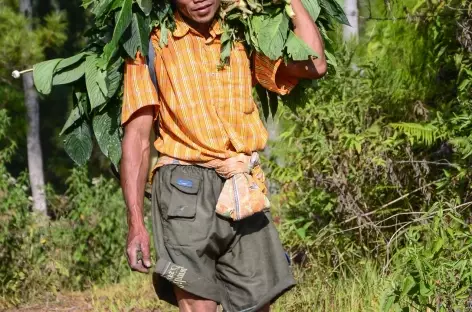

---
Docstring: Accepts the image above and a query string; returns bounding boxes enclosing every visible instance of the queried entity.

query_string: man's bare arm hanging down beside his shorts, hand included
[121,106,153,273]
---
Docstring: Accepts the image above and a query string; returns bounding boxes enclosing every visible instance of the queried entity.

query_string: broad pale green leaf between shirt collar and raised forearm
[257,12,289,60]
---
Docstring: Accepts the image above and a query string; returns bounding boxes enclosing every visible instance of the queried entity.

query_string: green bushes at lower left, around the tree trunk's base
[0,110,129,304]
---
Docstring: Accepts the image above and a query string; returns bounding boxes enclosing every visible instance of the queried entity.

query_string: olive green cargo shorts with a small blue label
[152,165,295,312]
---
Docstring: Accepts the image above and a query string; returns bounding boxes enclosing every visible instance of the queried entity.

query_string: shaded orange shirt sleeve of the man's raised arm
[253,53,298,95]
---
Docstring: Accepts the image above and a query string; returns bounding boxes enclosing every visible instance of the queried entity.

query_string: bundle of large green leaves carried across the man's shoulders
[29,0,347,166]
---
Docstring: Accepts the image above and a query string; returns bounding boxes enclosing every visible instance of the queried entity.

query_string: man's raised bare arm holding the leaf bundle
[277,0,328,79]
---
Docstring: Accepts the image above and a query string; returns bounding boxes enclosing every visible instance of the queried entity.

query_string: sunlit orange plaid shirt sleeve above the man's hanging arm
[121,52,159,125]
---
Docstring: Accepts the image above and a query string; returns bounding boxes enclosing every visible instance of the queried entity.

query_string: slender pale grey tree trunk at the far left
[20,0,47,215]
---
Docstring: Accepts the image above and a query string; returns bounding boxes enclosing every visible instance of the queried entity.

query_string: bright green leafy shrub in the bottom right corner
[382,204,472,312]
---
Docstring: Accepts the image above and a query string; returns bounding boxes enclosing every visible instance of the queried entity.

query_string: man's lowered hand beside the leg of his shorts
[126,226,151,273]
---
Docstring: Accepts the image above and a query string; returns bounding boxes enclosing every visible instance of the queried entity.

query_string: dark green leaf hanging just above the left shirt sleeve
[123,13,151,58]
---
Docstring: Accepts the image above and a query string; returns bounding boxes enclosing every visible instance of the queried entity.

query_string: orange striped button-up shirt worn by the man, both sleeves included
[121,14,297,162]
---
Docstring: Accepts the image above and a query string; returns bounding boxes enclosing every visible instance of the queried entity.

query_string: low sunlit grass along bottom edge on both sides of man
[1,264,387,312]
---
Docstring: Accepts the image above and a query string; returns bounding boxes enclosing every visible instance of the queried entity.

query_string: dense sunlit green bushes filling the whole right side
[270,0,472,311]
